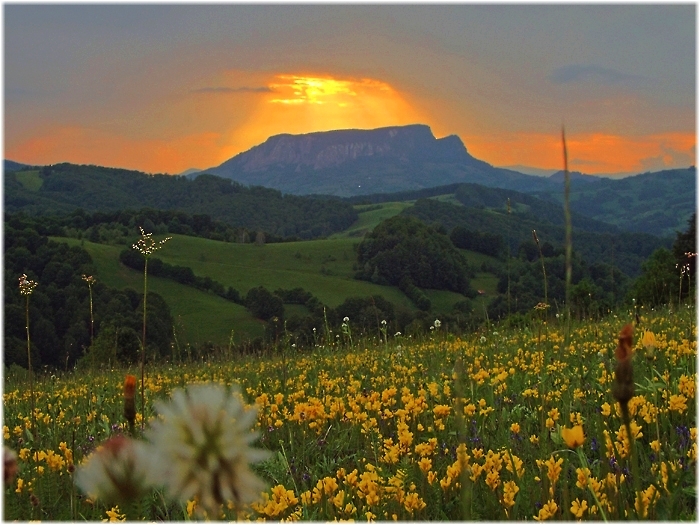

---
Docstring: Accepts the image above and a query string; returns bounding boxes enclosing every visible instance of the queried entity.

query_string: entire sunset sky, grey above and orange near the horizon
[3,3,696,174]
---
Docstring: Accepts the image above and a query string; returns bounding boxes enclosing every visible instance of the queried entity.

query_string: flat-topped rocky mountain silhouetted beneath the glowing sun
[190,124,556,197]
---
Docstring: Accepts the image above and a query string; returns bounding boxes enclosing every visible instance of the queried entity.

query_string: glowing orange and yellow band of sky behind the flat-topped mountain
[5,73,696,174]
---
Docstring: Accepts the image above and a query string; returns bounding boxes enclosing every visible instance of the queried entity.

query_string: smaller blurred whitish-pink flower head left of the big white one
[75,436,149,503]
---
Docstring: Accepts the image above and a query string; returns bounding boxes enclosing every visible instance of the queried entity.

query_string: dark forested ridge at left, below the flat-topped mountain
[3,164,357,239]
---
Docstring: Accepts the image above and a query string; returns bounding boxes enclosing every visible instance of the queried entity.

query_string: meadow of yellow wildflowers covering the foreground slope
[3,307,697,521]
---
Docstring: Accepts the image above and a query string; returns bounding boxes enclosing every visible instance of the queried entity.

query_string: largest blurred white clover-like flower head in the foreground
[147,384,269,516]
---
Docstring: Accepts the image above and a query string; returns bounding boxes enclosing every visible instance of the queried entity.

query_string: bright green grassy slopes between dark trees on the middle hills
[52,203,497,345]
